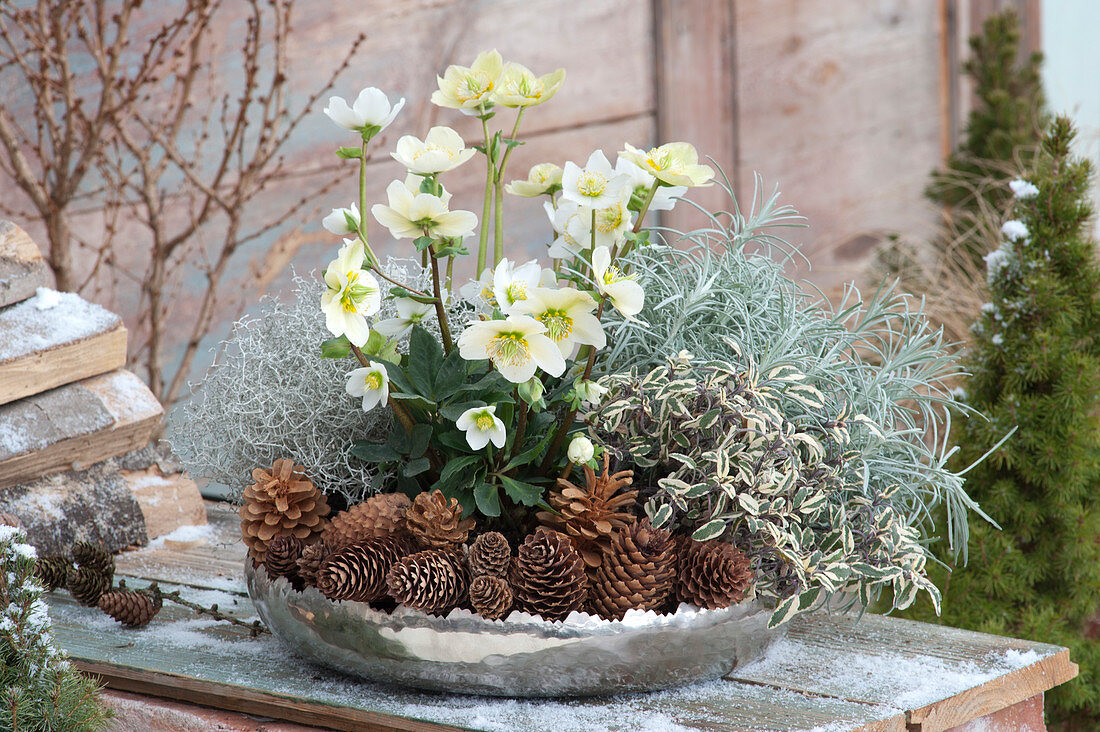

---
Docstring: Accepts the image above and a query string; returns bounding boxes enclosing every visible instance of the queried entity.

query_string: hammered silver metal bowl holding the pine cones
[245,560,785,697]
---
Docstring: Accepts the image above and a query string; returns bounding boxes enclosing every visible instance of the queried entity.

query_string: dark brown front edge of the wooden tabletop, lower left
[69,657,465,732]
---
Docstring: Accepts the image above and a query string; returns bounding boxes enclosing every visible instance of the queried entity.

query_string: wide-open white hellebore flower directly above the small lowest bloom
[459,315,565,384]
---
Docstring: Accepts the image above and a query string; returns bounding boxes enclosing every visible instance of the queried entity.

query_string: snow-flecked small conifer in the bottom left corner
[0,526,108,732]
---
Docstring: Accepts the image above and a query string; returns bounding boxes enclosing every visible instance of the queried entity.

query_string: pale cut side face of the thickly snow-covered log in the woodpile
[0,320,129,404]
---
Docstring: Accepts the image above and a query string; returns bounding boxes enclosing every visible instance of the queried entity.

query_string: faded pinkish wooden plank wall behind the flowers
[0,0,1041,383]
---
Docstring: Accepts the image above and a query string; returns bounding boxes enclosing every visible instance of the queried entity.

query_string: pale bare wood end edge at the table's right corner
[905,648,1078,732]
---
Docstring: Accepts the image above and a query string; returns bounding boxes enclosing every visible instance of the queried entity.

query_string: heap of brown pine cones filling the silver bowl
[241,457,752,621]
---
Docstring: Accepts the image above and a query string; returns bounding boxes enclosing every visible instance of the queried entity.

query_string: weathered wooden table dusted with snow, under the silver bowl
[51,504,1077,732]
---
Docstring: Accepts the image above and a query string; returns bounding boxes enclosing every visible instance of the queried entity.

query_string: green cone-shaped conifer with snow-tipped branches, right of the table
[942,117,1100,730]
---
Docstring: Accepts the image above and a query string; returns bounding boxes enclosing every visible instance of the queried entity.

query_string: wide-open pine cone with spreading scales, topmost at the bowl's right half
[536,452,638,567]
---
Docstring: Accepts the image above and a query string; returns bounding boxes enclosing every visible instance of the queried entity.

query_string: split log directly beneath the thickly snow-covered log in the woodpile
[0,371,164,489]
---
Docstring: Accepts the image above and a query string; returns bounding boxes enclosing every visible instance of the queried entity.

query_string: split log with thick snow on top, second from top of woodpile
[0,291,127,404]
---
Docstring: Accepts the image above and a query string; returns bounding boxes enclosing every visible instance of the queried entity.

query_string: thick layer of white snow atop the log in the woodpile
[0,287,121,362]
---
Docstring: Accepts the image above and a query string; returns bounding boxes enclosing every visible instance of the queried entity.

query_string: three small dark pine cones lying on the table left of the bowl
[34,542,161,627]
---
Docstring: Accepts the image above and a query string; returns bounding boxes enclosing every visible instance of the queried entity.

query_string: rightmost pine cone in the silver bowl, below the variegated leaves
[677,539,752,610]
